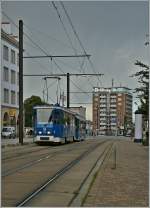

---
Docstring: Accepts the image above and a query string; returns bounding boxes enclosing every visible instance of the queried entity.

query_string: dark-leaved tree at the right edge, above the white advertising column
[131,60,149,120]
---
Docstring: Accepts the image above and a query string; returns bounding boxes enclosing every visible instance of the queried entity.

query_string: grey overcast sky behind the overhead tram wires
[2,1,149,119]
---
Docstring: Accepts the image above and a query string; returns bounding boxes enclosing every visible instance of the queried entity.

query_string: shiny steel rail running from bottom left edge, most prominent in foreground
[16,140,109,207]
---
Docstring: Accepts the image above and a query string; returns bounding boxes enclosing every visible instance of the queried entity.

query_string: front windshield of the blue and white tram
[37,108,53,124]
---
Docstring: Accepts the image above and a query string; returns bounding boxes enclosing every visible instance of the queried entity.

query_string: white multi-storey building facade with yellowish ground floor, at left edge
[1,29,19,131]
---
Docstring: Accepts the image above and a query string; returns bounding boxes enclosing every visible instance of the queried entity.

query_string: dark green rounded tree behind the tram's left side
[24,95,48,127]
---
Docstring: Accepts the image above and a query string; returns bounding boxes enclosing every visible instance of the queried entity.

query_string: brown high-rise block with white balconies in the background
[93,87,132,135]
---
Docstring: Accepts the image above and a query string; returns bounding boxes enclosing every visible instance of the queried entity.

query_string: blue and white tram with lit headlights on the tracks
[33,105,86,143]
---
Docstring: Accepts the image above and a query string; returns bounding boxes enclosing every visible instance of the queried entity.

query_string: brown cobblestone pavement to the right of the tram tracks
[83,140,149,207]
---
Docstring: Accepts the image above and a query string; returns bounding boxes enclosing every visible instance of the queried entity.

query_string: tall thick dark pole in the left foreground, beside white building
[19,20,23,145]
